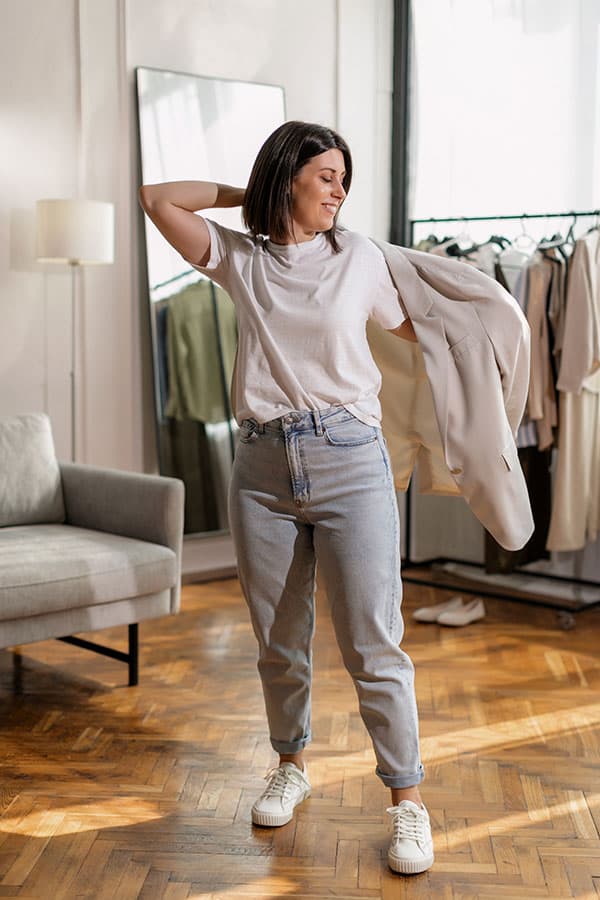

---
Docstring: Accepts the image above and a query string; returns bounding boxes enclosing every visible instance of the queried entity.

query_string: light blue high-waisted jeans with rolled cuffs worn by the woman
[229,406,423,788]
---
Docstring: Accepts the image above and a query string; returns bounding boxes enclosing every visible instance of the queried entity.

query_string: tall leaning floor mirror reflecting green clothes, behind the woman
[136,68,285,535]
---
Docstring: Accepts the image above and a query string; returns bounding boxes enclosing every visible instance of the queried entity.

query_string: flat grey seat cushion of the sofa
[0,525,177,621]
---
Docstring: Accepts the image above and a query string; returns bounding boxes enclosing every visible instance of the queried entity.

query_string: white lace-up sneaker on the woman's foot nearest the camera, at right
[387,800,433,875]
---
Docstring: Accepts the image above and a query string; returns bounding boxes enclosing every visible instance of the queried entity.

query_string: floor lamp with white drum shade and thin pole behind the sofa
[36,200,115,462]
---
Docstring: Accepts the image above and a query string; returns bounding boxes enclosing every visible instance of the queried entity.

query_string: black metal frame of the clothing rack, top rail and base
[402,209,600,629]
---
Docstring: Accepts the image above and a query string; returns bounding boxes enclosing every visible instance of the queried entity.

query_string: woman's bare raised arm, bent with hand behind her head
[140,181,245,266]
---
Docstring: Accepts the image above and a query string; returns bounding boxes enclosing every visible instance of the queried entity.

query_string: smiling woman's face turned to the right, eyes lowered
[291,148,346,243]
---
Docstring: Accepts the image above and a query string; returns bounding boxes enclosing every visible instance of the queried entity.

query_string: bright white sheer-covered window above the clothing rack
[410,0,600,230]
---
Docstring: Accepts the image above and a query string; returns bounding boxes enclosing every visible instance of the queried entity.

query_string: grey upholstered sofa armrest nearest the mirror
[60,463,184,565]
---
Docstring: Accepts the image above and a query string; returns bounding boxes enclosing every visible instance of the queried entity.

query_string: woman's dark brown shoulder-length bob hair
[242,121,352,253]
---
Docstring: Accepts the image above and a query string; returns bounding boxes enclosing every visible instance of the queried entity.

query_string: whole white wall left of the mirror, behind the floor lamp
[0,0,135,468]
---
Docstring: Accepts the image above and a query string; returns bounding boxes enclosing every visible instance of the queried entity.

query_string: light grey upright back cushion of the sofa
[0,413,65,528]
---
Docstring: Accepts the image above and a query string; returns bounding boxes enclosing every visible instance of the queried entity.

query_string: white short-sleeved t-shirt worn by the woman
[194,219,406,426]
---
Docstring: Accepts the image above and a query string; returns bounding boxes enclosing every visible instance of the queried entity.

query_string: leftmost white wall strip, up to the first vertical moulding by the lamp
[0,0,77,458]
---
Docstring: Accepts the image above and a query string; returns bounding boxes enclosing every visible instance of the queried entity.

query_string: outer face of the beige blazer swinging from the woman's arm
[375,241,534,550]
